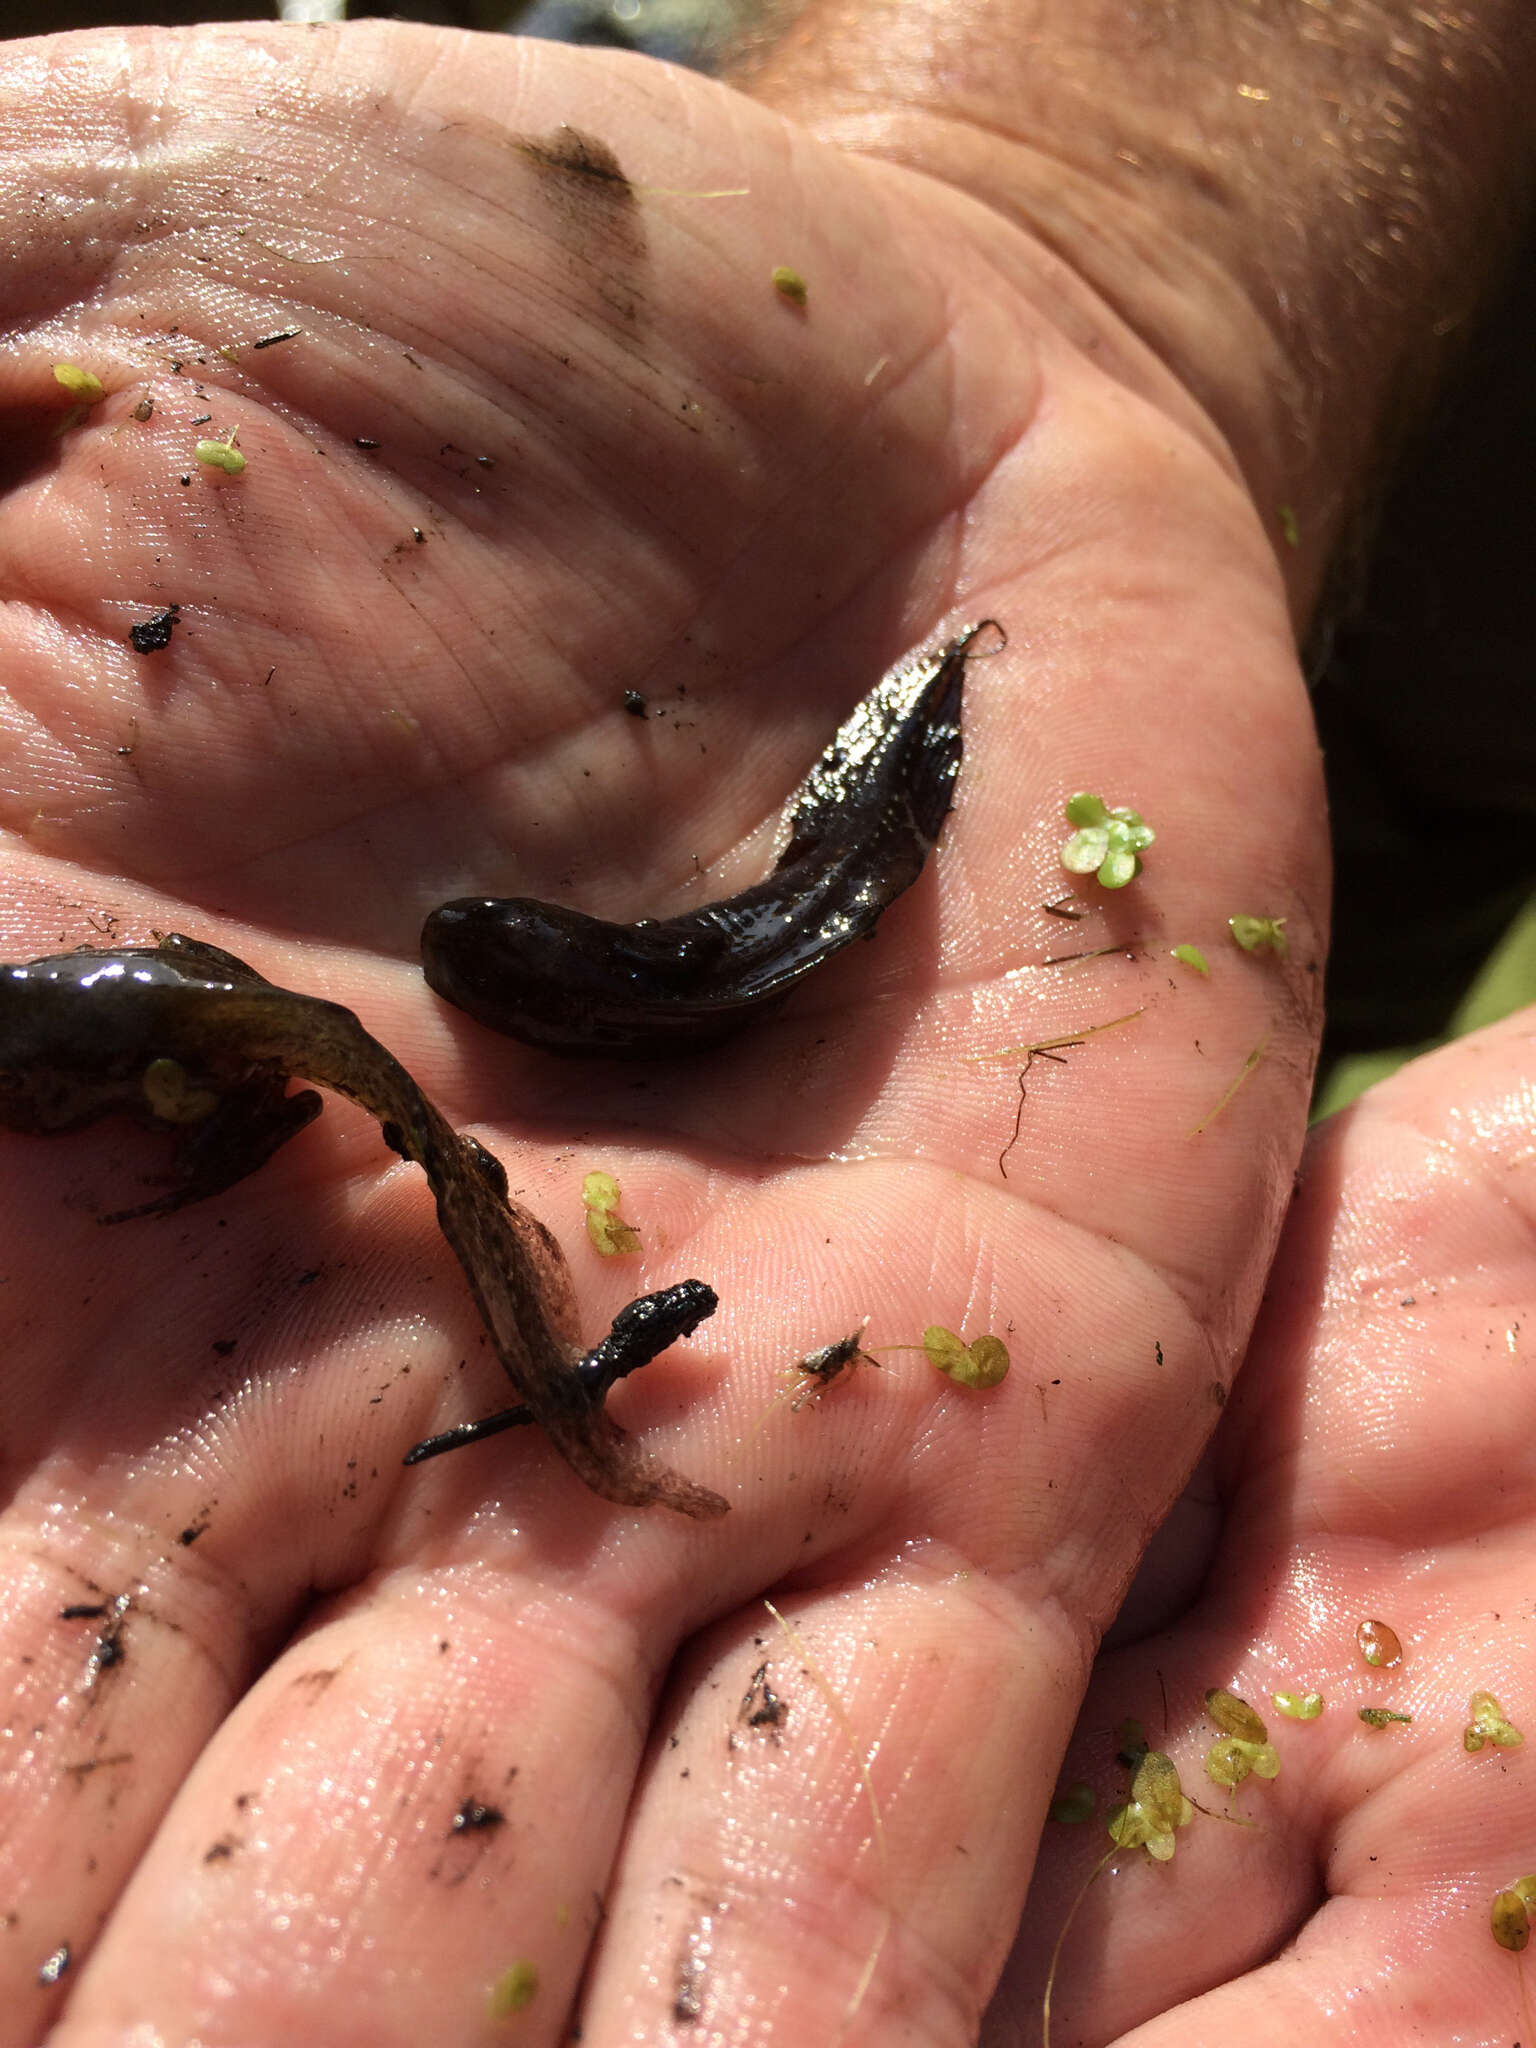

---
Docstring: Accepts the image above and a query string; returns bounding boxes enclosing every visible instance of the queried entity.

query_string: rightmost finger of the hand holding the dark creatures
[582,1544,1081,2048]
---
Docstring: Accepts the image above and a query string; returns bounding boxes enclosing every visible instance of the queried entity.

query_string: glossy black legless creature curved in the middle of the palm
[422,618,995,1059]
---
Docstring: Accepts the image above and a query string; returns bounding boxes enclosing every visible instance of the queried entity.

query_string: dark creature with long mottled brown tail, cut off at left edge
[0,934,727,1518]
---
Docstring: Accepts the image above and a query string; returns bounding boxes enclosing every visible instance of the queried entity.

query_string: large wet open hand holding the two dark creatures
[0,27,1325,2048]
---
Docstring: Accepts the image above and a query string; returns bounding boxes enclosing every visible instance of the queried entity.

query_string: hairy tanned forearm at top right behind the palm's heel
[735,0,1536,592]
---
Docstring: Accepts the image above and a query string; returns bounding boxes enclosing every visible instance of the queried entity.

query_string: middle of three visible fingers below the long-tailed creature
[51,1556,651,2048]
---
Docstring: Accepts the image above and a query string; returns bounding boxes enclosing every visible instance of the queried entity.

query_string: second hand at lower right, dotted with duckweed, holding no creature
[981,1010,1536,2048]
